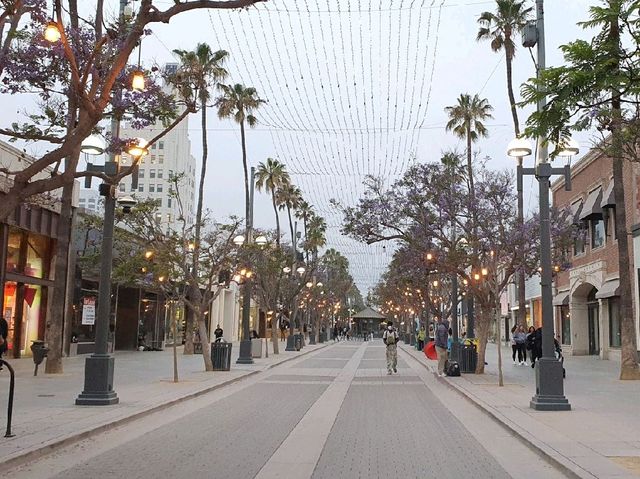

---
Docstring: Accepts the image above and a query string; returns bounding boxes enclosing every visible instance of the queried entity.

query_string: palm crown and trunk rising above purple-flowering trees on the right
[445,93,493,198]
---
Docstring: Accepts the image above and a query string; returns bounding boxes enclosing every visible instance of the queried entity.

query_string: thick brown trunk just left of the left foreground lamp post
[44,172,75,374]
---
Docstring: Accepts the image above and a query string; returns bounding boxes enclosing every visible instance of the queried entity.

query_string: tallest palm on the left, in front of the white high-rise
[172,43,228,360]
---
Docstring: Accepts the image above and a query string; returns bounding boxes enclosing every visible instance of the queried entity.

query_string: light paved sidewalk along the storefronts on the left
[0,342,325,466]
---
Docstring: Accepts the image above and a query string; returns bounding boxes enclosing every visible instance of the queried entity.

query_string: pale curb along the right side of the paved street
[401,347,597,479]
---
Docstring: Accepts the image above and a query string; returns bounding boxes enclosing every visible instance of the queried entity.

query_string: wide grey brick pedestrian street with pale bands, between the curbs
[4,341,566,479]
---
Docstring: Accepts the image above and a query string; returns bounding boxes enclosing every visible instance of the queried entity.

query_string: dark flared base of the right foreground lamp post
[529,358,571,411]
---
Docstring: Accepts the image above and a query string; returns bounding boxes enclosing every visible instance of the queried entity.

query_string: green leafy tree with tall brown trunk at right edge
[522,0,640,379]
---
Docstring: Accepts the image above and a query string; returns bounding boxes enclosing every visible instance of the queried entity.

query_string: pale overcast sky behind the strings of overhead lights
[3,0,596,295]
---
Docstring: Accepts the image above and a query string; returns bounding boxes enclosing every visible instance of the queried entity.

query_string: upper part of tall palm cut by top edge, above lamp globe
[476,0,533,136]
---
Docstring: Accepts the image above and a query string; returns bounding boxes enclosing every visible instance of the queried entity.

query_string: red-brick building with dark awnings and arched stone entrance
[552,150,640,359]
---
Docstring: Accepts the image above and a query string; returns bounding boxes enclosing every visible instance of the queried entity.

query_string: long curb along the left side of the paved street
[2,344,327,471]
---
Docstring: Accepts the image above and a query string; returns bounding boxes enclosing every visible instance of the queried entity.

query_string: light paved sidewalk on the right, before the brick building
[401,344,640,479]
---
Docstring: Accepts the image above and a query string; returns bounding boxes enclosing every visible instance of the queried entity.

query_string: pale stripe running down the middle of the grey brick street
[256,343,367,479]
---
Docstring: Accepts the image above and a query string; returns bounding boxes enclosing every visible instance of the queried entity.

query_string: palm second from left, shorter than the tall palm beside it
[215,83,265,238]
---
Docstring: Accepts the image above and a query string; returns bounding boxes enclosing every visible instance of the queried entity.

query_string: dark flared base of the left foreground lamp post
[76,354,120,406]
